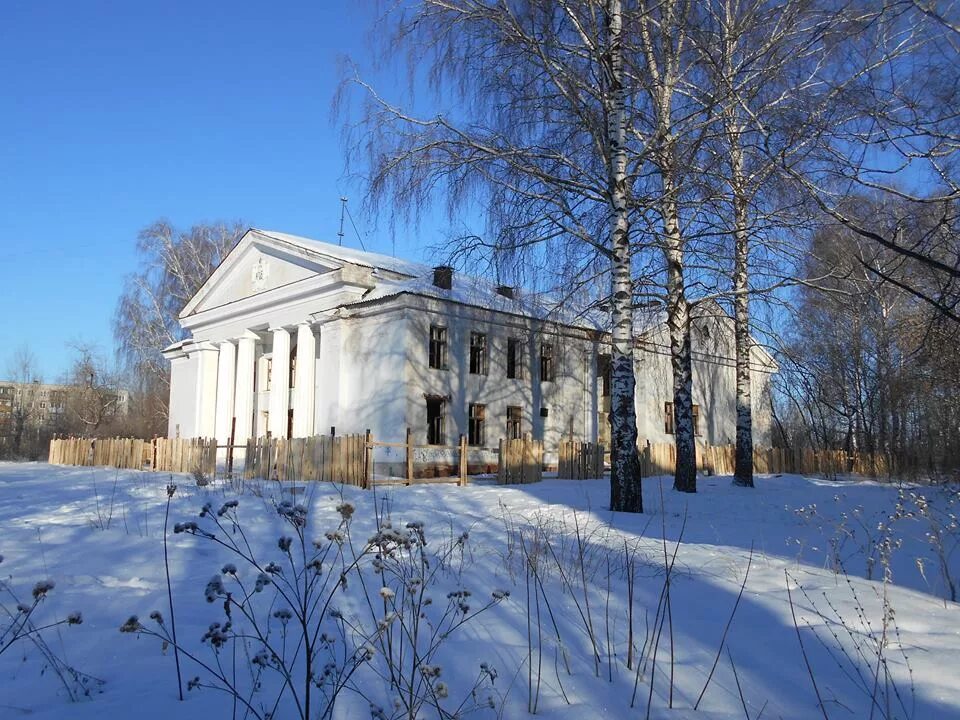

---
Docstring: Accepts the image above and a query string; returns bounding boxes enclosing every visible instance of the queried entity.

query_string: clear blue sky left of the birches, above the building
[0,0,446,380]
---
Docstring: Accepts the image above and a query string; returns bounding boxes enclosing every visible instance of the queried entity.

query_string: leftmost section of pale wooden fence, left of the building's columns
[48,438,217,476]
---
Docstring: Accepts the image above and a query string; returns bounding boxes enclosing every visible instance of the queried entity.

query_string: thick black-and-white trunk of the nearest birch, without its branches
[605,0,643,512]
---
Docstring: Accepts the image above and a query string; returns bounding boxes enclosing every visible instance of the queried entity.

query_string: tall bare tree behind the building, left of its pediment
[113,220,245,428]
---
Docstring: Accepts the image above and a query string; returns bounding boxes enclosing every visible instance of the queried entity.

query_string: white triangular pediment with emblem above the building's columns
[180,230,343,317]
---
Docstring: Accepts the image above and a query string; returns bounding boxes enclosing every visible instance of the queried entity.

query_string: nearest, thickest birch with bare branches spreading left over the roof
[347,0,646,512]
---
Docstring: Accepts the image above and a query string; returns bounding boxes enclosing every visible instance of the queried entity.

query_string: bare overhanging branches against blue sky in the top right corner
[782,0,960,322]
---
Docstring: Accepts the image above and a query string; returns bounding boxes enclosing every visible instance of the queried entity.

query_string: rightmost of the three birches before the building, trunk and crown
[694,0,837,487]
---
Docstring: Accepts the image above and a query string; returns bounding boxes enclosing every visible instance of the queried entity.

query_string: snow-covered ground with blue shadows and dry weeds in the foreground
[0,463,960,720]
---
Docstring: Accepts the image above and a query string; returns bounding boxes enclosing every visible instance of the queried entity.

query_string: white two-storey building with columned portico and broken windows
[164,230,775,456]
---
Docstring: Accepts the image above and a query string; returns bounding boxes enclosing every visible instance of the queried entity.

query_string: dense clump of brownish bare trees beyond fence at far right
[785,195,960,475]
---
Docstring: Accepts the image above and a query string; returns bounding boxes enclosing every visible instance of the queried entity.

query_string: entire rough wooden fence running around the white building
[49,428,900,488]
